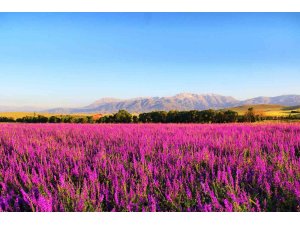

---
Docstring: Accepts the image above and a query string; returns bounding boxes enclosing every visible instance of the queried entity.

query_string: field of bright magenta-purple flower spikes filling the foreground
[0,123,300,211]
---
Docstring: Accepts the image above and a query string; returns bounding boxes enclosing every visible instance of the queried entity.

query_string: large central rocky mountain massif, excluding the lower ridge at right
[47,93,239,113]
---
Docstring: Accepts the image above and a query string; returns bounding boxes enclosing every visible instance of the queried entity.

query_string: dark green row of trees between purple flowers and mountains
[0,108,300,123]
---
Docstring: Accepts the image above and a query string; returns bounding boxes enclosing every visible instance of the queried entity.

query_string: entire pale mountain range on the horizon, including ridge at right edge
[47,93,300,113]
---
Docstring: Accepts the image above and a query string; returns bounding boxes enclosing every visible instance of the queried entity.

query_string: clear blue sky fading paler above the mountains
[0,13,300,107]
